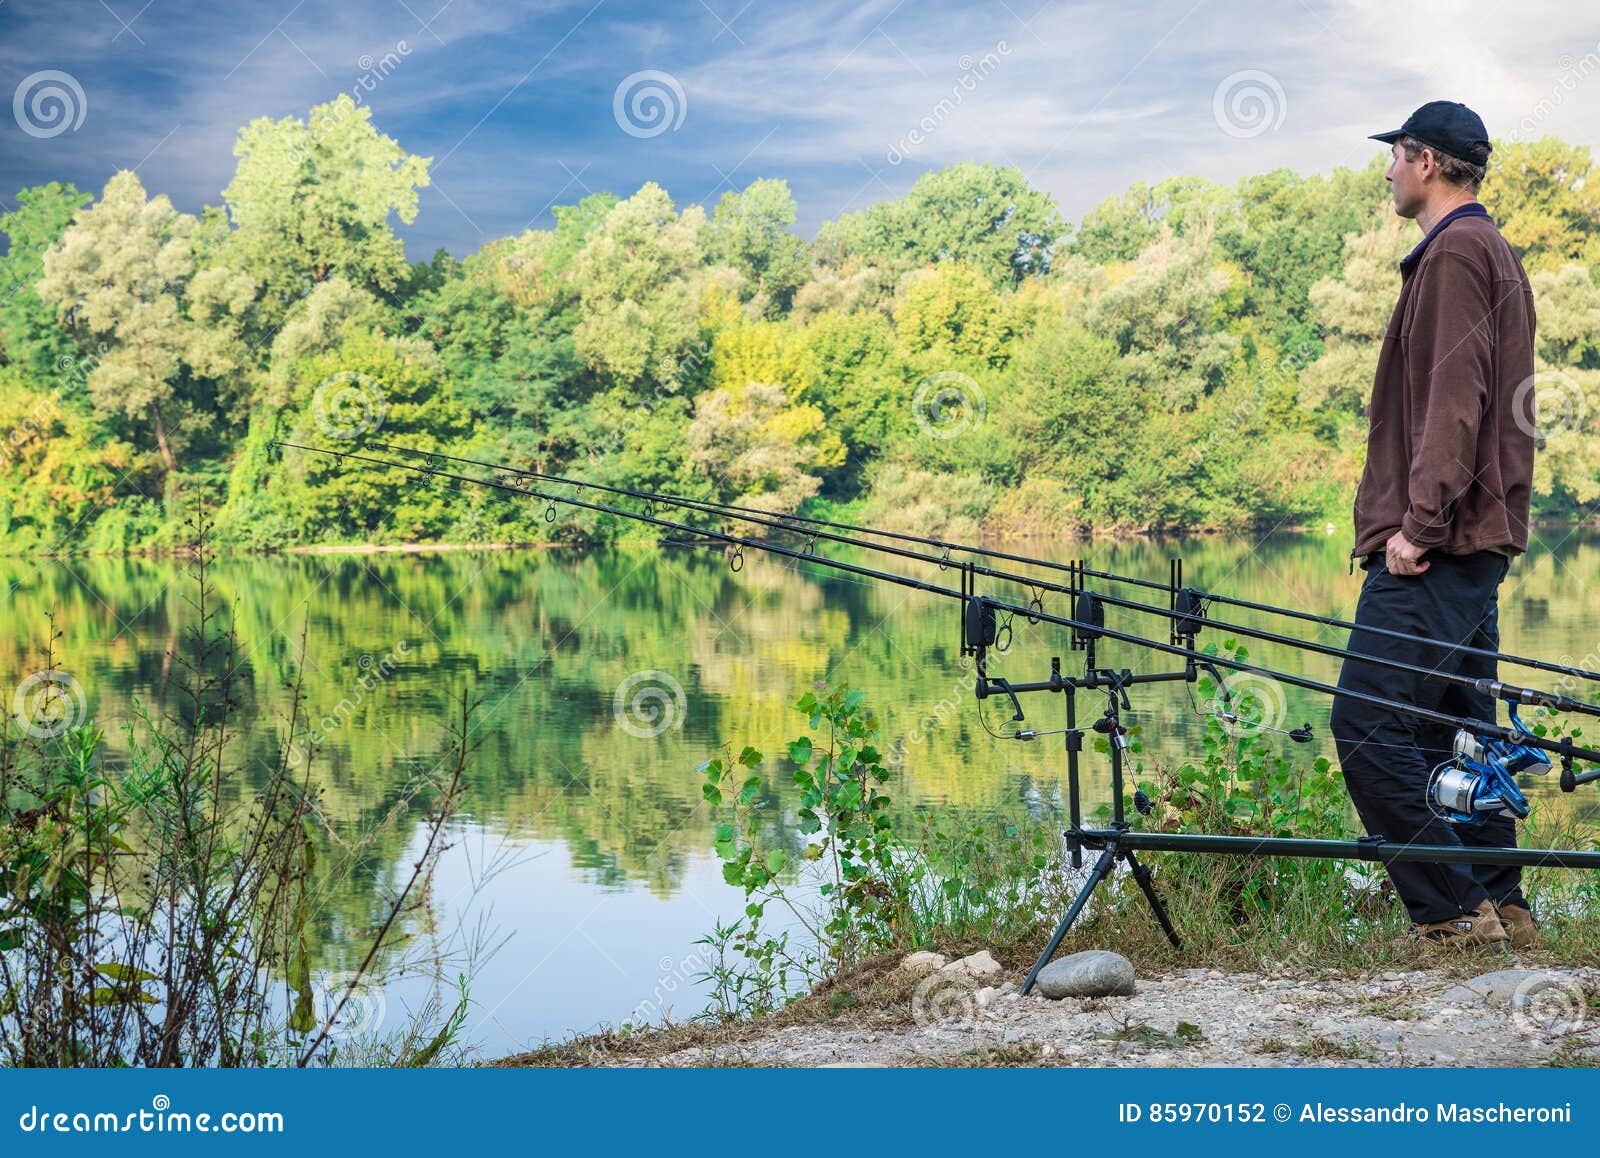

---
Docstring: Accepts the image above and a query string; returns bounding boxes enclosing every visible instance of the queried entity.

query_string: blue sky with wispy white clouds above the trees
[0,0,1600,258]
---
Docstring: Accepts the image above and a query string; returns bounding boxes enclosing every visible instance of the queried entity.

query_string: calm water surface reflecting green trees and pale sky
[0,529,1600,1048]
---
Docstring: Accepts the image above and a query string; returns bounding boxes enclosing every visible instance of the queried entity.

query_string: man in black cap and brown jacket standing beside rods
[1331,101,1539,948]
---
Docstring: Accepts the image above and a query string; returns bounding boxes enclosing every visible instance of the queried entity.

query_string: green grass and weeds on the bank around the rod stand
[498,710,1600,1065]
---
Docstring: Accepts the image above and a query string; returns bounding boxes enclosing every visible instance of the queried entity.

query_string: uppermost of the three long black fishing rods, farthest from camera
[366,440,1600,690]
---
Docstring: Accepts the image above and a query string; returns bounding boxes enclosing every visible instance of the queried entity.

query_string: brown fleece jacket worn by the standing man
[1354,206,1534,557]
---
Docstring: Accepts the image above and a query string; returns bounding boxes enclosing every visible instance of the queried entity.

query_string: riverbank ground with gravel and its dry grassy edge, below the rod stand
[496,953,1600,1068]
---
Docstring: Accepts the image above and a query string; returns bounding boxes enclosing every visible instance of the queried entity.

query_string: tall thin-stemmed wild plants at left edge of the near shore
[0,517,470,1067]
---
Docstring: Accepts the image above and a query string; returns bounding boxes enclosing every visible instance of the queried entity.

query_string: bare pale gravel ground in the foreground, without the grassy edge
[621,969,1600,1068]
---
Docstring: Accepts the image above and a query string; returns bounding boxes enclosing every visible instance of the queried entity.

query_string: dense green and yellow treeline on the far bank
[0,98,1600,550]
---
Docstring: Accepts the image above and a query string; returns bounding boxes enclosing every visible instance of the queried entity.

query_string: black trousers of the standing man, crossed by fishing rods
[1331,550,1528,924]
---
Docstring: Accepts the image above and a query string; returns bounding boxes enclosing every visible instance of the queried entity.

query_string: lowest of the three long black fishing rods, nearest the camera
[275,440,1600,782]
